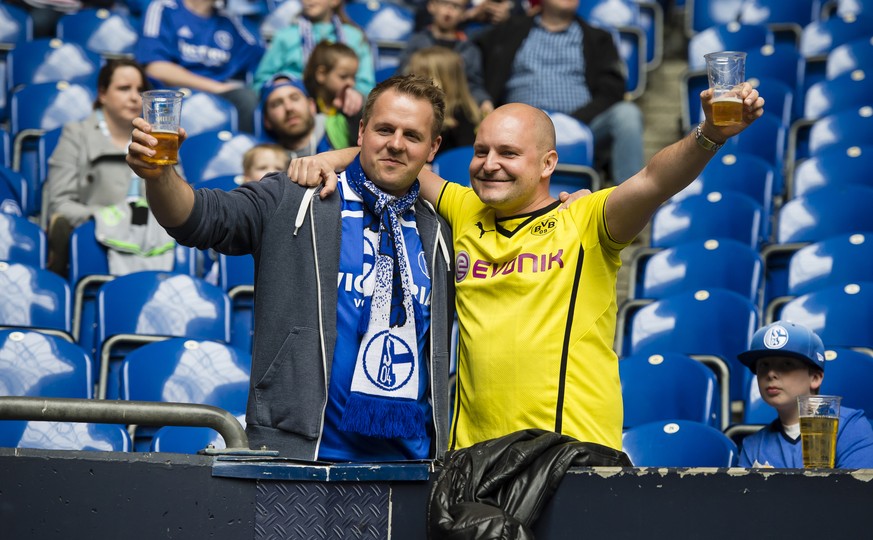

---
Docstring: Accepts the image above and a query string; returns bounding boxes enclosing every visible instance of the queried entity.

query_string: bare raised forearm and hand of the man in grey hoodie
[127,118,194,228]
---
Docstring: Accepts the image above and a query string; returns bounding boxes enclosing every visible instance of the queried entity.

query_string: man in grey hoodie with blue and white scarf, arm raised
[127,76,454,461]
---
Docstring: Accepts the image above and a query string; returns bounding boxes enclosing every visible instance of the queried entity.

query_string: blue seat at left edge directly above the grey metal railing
[0,328,94,399]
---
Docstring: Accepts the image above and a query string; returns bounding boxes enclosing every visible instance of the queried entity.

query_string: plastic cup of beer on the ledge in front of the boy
[797,395,841,469]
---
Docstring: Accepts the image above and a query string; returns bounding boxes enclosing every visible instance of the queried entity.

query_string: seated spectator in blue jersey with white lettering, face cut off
[135,0,264,133]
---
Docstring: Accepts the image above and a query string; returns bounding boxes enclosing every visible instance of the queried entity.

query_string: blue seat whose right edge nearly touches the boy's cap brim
[616,288,758,400]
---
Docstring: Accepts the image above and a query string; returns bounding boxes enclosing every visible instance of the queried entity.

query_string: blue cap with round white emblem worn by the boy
[737,321,825,373]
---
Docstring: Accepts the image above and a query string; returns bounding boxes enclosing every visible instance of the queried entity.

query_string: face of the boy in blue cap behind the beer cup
[755,356,824,423]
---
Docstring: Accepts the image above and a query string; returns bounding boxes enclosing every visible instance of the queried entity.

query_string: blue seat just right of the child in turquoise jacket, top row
[344,0,415,69]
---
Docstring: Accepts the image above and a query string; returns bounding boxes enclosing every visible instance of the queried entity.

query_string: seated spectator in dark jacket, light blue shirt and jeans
[477,0,645,184]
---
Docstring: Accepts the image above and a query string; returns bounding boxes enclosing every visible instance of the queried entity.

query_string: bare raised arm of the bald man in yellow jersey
[606,83,764,242]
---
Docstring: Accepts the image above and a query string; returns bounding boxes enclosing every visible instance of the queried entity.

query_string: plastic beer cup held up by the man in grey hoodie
[142,90,182,165]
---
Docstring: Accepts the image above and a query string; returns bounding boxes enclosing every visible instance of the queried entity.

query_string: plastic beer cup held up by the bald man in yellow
[703,51,746,126]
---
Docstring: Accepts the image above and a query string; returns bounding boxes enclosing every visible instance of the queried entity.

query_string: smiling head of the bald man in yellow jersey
[470,104,558,217]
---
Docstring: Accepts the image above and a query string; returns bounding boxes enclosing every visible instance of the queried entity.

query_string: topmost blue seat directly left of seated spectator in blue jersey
[55,8,139,58]
